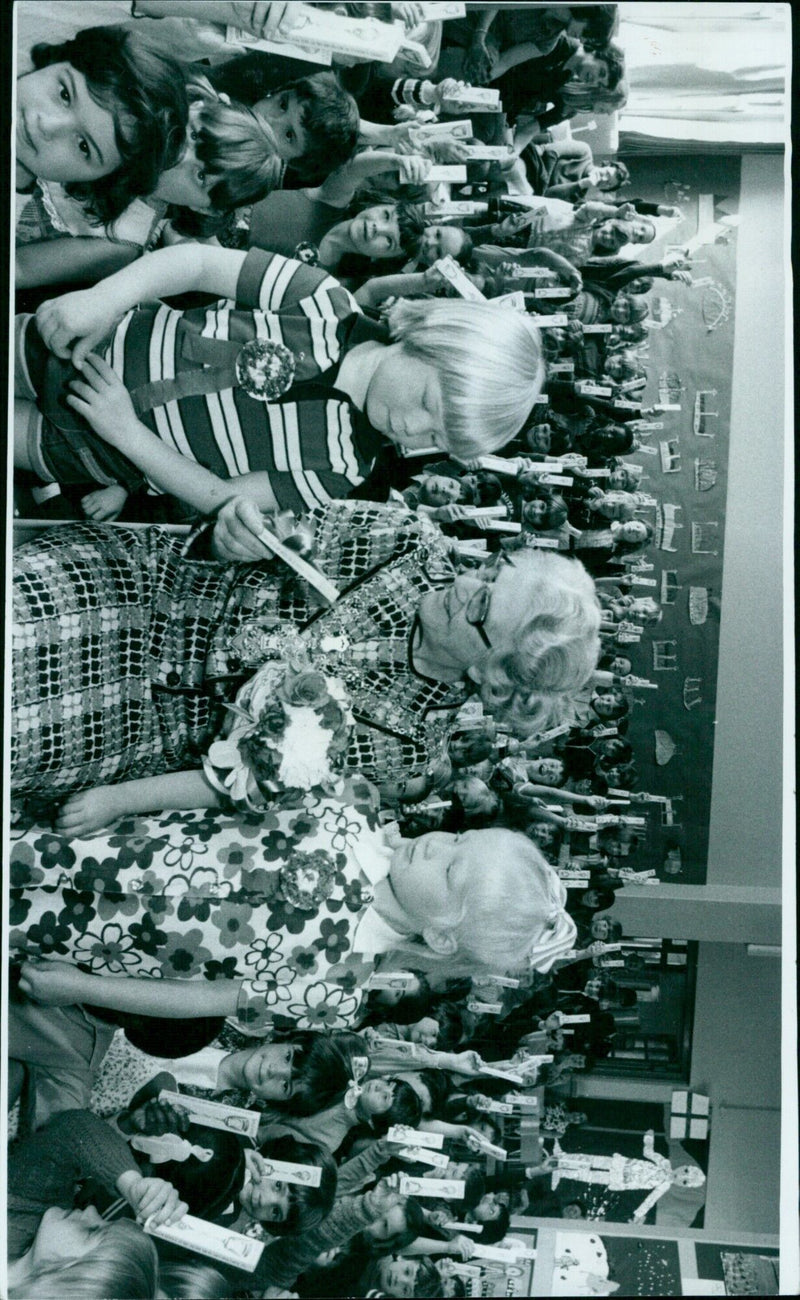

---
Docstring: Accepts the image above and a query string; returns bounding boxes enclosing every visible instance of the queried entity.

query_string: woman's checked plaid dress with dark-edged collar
[12,502,464,798]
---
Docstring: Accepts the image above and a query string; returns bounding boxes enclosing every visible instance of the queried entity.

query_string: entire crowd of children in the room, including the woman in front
[8,0,702,1300]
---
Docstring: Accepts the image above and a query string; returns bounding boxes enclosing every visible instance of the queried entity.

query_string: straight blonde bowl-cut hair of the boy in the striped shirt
[389,298,545,458]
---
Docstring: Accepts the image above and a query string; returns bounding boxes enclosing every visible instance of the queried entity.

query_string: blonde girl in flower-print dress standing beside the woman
[12,821,575,1034]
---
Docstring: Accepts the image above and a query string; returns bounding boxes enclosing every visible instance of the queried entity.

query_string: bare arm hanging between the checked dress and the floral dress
[55,768,221,839]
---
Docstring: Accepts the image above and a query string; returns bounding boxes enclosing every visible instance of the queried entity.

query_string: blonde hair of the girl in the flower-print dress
[387,827,576,978]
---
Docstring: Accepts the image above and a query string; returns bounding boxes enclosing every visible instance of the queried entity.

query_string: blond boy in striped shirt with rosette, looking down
[14,244,544,514]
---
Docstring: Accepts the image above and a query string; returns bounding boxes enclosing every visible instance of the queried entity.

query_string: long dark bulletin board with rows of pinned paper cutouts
[606,156,757,884]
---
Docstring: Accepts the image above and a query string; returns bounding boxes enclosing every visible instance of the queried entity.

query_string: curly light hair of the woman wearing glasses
[480,549,601,737]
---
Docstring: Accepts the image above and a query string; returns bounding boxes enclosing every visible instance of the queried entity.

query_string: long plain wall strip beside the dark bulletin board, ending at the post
[708,153,788,885]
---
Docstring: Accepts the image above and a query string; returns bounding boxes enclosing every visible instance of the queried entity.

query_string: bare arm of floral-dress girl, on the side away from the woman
[20,957,242,1021]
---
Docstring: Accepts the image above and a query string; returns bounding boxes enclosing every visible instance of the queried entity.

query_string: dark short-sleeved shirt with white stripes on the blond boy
[105,248,388,512]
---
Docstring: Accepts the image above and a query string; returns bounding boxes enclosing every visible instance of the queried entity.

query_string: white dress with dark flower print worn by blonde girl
[9,780,384,1034]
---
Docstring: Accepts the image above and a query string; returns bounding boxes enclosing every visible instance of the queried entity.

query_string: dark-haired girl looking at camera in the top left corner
[16,27,189,289]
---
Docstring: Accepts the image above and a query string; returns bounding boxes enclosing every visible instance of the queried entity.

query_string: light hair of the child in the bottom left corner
[8,1219,159,1300]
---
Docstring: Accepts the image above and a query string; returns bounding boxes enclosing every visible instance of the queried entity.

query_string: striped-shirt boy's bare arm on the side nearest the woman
[66,352,280,515]
